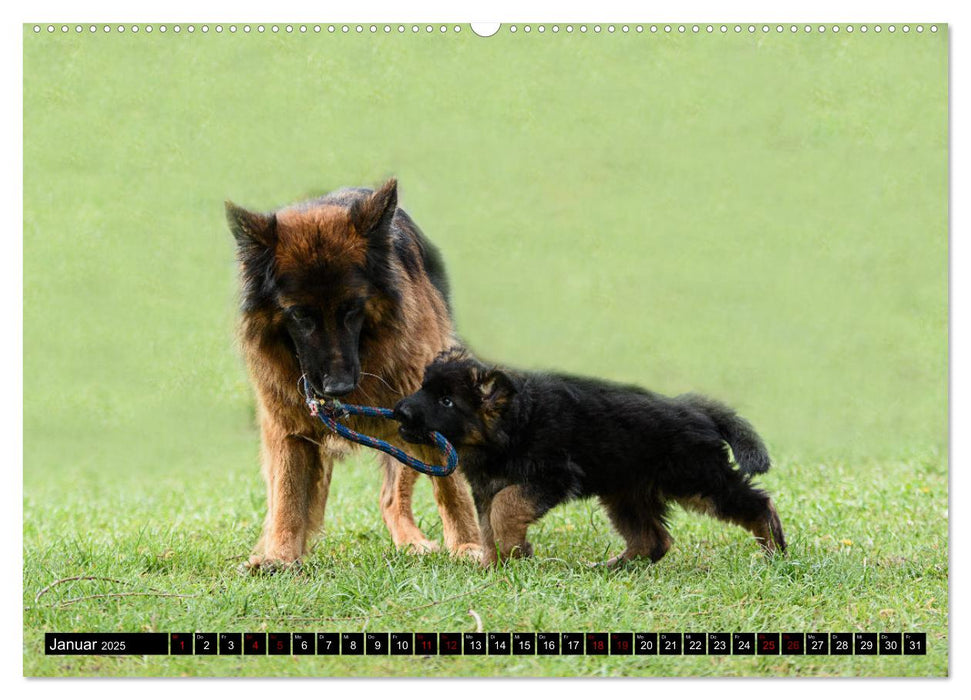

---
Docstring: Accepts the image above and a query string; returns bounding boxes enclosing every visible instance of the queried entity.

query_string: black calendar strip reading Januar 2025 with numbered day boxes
[44,632,927,656]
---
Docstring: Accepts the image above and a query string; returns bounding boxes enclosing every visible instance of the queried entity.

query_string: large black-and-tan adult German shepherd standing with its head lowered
[226,179,479,569]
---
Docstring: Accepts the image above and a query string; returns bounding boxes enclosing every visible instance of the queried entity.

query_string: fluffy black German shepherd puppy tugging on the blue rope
[395,350,786,565]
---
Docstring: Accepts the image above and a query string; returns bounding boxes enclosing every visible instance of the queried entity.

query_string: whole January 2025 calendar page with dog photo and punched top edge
[22,20,950,677]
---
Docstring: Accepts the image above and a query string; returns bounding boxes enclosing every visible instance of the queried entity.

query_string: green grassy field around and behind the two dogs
[23,27,948,676]
